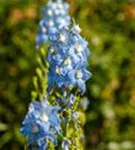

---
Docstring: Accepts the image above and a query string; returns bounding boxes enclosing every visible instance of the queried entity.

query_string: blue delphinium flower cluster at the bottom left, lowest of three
[21,100,61,150]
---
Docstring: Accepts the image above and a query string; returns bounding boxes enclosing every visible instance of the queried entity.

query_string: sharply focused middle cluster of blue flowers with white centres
[48,24,91,93]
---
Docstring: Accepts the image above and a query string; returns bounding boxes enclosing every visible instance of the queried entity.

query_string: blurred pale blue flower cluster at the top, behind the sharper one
[36,0,70,48]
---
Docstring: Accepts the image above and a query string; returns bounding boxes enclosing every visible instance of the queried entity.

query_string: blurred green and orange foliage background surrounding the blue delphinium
[0,0,135,150]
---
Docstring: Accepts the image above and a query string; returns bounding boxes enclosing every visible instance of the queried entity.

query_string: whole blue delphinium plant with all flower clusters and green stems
[21,0,91,150]
